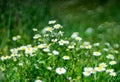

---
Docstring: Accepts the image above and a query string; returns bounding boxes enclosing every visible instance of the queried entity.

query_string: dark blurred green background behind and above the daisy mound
[0,0,120,54]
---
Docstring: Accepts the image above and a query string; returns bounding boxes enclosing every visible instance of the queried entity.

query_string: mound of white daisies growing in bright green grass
[0,20,118,82]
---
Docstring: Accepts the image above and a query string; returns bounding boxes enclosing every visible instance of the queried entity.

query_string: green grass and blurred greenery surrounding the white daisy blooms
[0,0,120,82]
